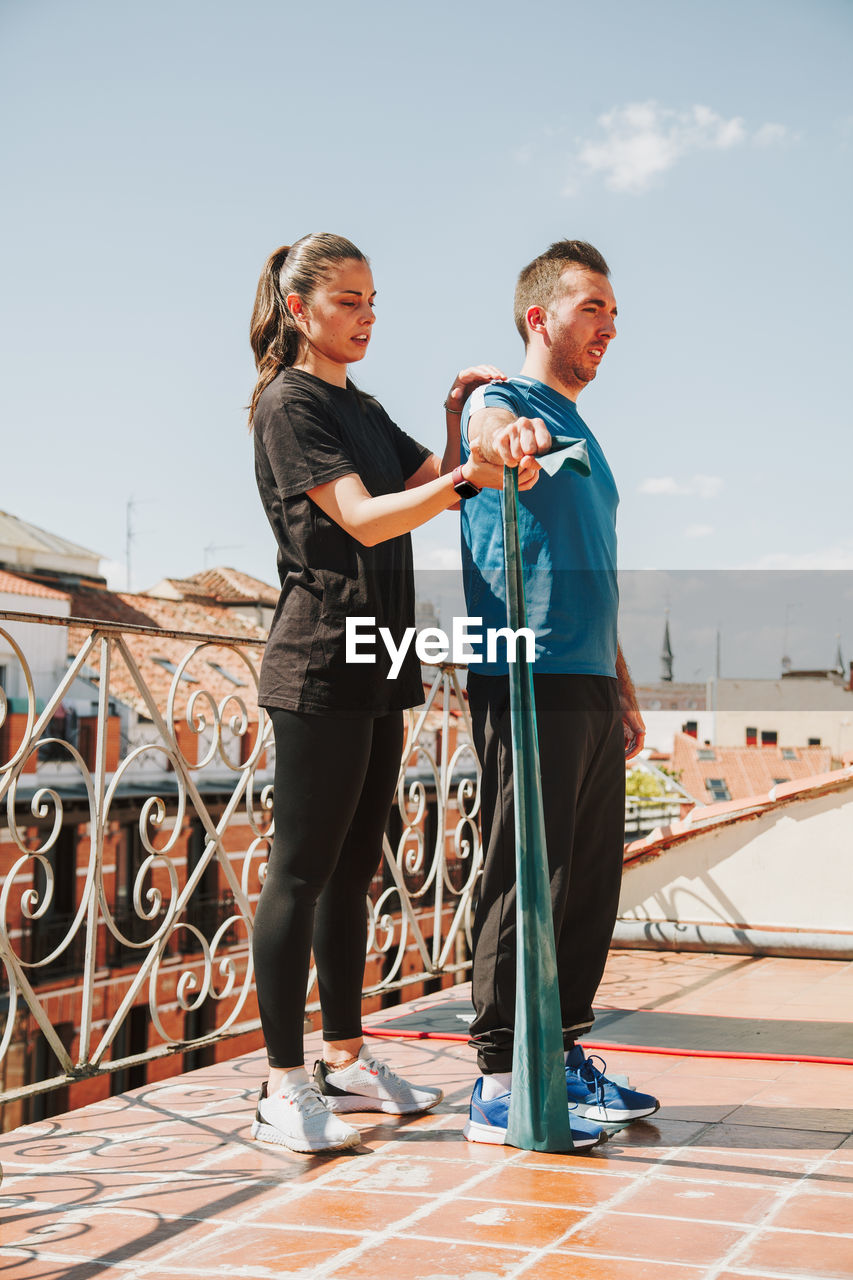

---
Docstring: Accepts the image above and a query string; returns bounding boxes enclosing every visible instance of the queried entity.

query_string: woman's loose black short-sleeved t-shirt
[254,369,430,718]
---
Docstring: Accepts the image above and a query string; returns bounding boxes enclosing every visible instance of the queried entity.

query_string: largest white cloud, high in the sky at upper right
[575,101,790,192]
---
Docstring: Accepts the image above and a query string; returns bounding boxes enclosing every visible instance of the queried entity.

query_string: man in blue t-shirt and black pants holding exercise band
[462,241,658,1149]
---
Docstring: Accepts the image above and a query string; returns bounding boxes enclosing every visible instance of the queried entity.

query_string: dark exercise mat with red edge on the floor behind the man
[368,1000,853,1059]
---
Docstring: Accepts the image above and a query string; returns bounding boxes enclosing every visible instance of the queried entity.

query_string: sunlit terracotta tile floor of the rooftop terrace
[0,951,853,1280]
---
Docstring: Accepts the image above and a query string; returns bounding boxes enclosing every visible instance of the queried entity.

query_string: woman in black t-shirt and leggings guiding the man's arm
[250,233,535,1152]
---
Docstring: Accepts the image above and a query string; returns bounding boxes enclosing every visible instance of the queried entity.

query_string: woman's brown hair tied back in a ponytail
[248,232,368,430]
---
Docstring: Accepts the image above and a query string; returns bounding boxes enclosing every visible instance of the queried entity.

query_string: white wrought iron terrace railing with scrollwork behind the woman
[0,611,482,1103]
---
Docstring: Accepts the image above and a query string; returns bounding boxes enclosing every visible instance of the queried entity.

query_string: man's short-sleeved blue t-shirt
[461,378,619,676]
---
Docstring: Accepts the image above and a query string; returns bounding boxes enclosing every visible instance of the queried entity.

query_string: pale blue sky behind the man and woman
[0,0,853,678]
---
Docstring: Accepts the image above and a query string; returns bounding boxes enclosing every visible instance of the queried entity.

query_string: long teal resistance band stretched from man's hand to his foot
[502,436,589,1151]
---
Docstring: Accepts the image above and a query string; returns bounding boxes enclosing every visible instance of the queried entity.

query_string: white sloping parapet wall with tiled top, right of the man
[615,771,853,957]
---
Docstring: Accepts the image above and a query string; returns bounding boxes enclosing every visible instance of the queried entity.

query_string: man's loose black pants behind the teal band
[467,673,625,1073]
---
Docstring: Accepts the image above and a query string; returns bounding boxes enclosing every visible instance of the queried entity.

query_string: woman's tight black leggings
[252,708,402,1068]
